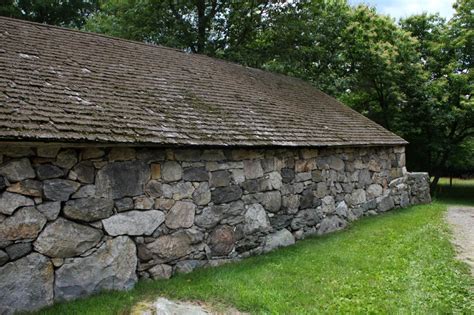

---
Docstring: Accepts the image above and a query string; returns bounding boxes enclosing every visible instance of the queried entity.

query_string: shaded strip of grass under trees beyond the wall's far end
[435,178,474,206]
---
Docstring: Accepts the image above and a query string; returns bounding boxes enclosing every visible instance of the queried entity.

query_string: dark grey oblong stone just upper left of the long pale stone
[63,198,114,222]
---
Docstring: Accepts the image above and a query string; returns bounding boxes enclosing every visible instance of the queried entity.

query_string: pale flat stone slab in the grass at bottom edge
[130,297,247,315]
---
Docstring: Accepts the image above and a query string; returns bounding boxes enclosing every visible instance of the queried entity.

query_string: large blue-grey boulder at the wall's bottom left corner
[0,253,54,314]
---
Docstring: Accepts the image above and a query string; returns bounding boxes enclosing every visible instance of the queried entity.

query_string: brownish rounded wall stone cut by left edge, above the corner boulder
[0,207,46,242]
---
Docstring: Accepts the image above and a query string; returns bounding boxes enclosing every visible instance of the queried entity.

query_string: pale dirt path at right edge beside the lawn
[446,206,474,276]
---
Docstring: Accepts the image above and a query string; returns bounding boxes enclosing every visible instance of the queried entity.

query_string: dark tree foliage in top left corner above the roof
[0,0,98,28]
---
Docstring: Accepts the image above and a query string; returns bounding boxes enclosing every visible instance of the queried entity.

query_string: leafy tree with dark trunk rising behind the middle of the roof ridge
[86,0,270,59]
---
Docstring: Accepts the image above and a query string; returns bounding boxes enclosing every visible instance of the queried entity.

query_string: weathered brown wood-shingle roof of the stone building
[0,18,406,146]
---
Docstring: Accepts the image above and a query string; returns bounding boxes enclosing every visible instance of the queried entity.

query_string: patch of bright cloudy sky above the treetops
[349,0,454,19]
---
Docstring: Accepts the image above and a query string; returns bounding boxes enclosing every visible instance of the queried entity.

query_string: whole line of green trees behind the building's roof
[0,0,474,189]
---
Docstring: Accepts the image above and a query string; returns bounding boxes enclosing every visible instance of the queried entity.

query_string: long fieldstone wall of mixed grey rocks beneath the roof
[0,146,430,313]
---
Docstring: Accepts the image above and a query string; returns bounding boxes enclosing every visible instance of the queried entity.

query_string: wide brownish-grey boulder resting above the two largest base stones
[33,218,102,258]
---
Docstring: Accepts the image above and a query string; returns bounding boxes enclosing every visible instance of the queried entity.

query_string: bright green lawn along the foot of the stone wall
[40,202,474,314]
